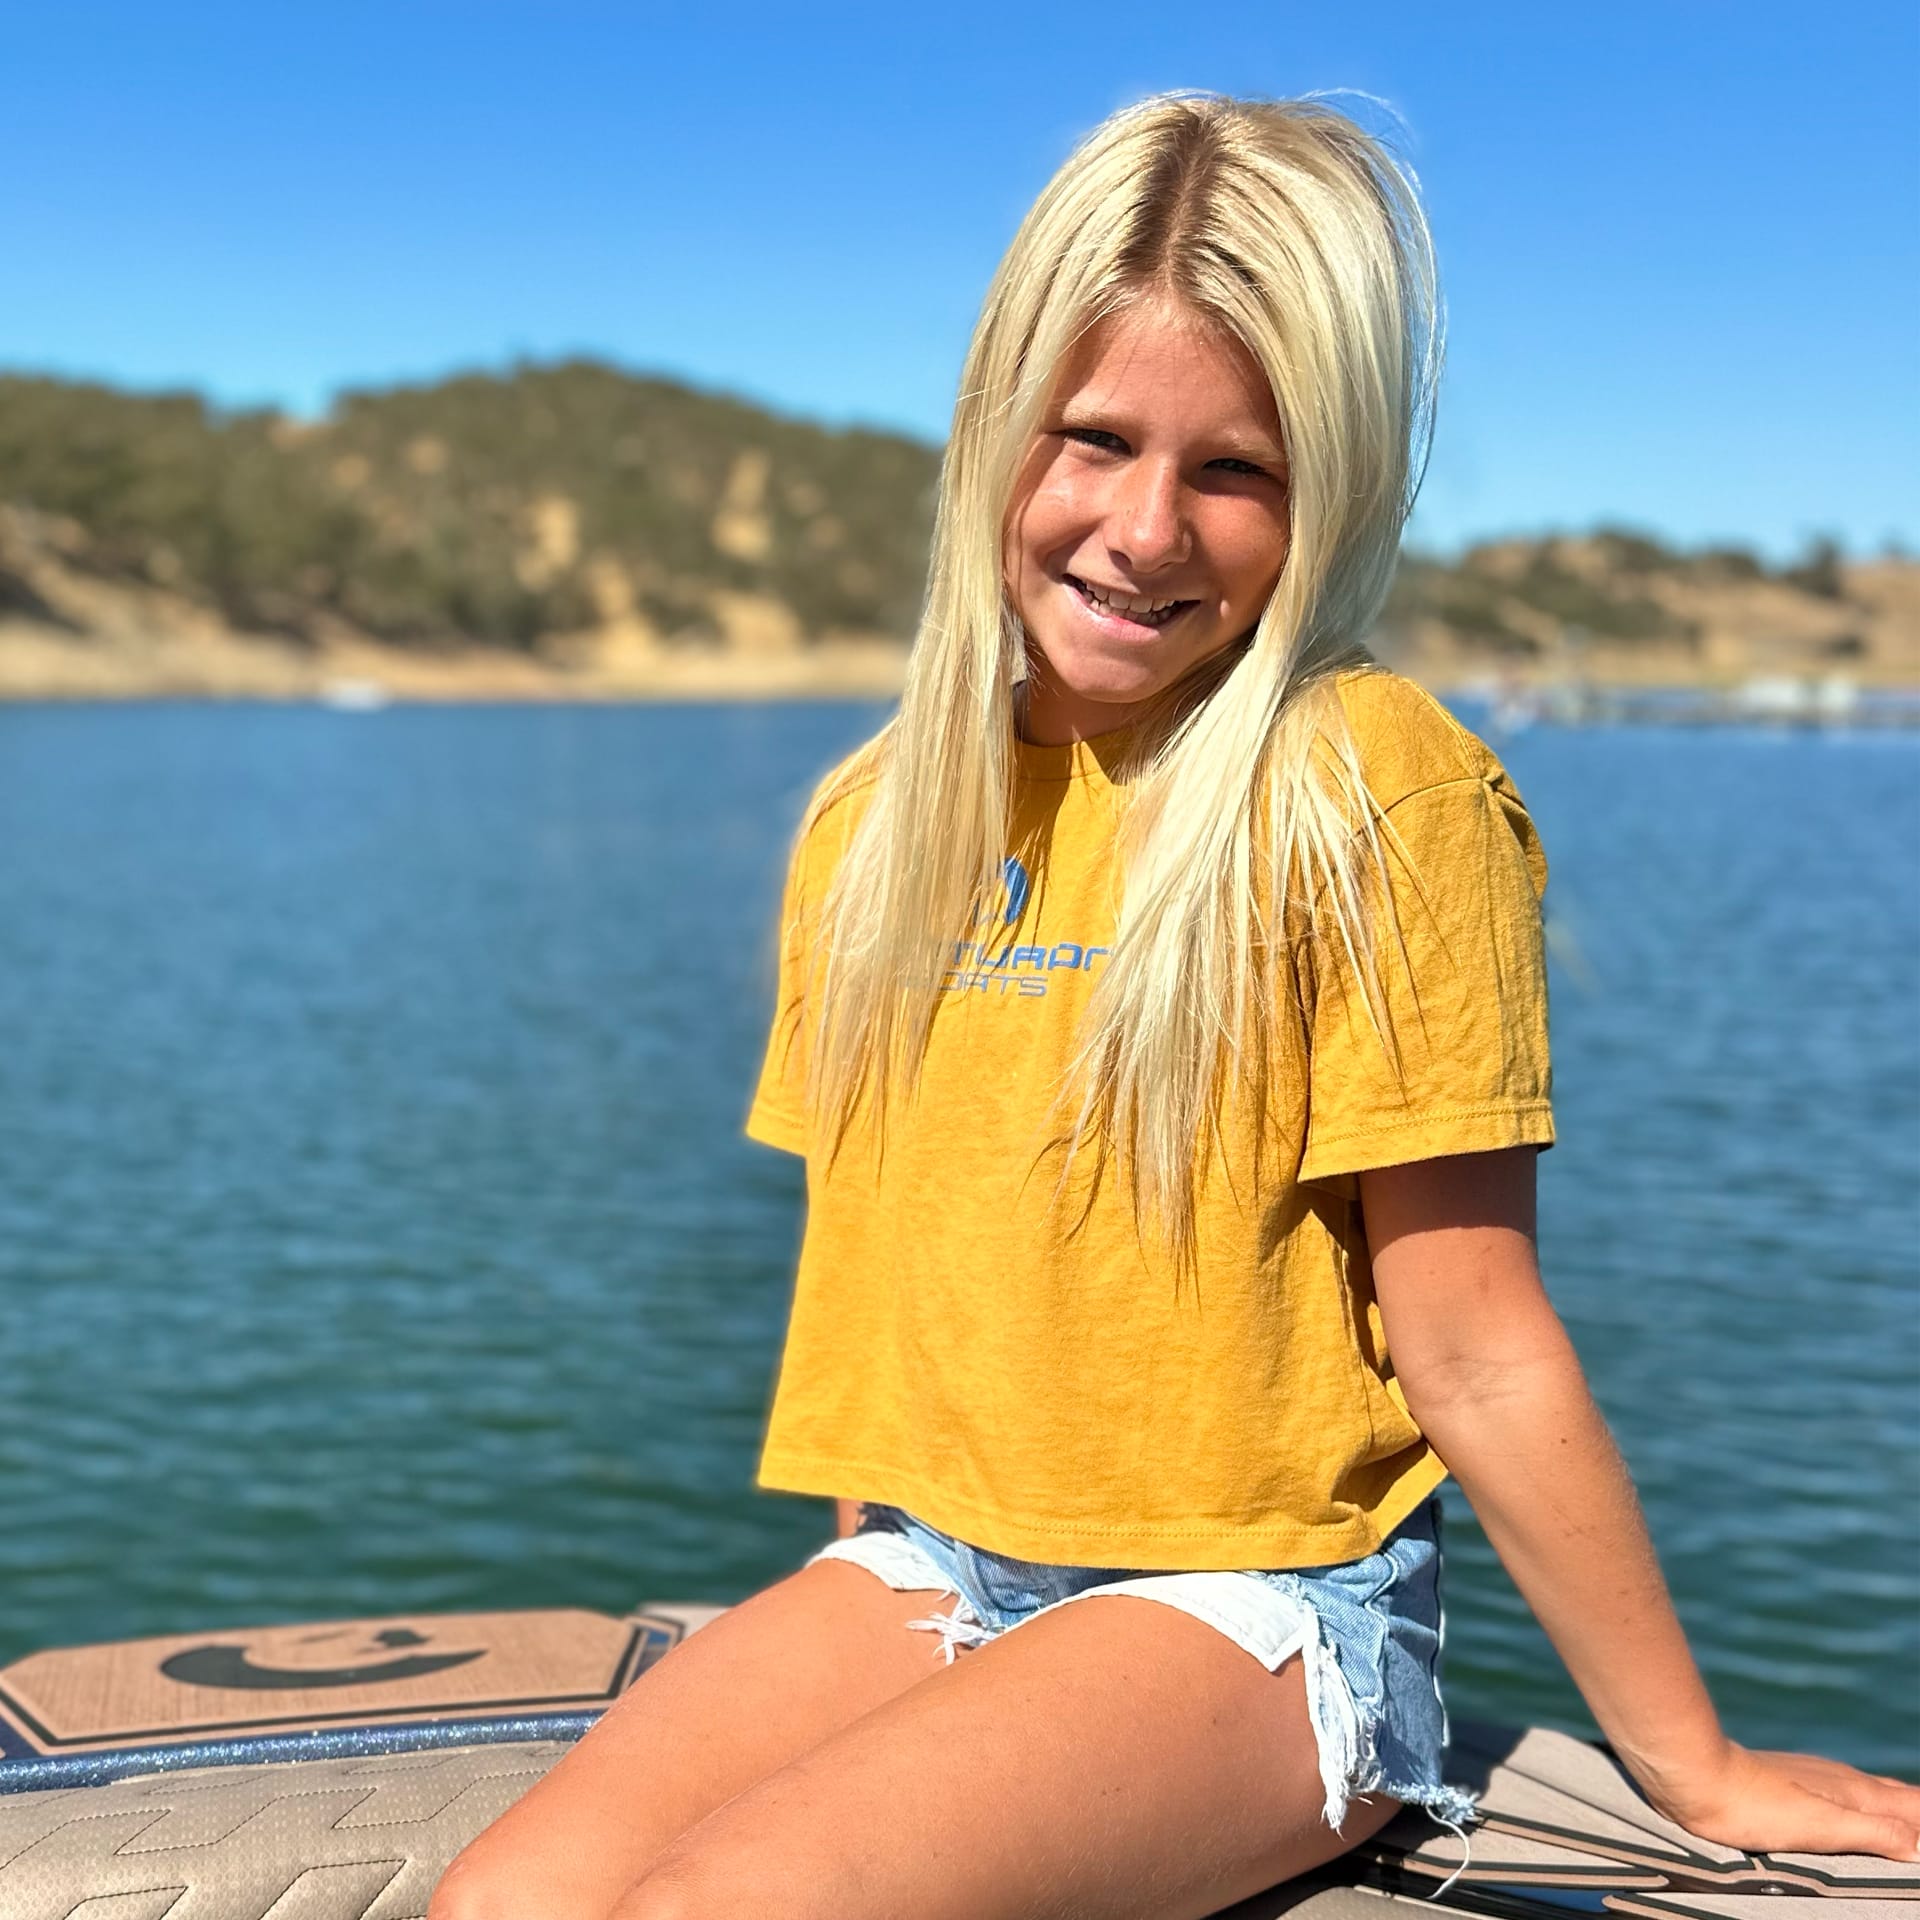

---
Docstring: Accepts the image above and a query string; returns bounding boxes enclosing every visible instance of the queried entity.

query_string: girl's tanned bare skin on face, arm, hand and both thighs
[430,299,1920,1920]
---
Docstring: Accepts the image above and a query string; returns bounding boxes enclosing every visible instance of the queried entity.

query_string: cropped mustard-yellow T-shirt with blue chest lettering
[747,670,1553,1569]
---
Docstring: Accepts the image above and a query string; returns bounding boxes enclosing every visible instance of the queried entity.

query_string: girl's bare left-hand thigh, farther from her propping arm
[428,1561,943,1920]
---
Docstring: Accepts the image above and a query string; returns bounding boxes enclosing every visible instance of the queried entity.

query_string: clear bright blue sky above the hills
[0,0,1920,555]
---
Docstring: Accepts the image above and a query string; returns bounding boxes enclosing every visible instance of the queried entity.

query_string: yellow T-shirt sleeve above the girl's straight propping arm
[1300,764,1553,1181]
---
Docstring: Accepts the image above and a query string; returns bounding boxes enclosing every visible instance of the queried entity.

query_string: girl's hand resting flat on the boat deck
[1647,1741,1920,1860]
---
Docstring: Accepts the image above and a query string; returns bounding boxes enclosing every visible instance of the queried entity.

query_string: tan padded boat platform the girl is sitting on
[0,1603,1920,1920]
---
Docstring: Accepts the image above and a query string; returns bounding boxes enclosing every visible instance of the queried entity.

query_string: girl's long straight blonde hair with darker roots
[808,94,1440,1263]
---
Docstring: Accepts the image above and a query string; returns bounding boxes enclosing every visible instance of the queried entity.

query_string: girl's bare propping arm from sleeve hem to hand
[1361,1146,1920,1860]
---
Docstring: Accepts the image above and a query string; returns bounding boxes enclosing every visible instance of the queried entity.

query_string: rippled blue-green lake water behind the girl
[0,705,1920,1770]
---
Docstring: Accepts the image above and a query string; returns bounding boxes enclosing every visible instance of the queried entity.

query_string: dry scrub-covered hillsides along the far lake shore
[0,361,1920,699]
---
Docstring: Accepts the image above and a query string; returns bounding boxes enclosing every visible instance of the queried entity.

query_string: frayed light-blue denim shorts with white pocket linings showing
[808,1496,1473,1828]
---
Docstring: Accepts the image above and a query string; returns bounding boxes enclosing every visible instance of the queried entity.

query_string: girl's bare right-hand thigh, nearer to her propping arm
[614,1594,1394,1920]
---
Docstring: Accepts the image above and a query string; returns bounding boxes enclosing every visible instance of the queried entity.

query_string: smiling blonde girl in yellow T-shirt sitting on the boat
[432,96,1920,1920]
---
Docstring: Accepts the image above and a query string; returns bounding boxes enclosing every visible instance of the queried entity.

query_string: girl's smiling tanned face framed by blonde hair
[1006,305,1288,745]
